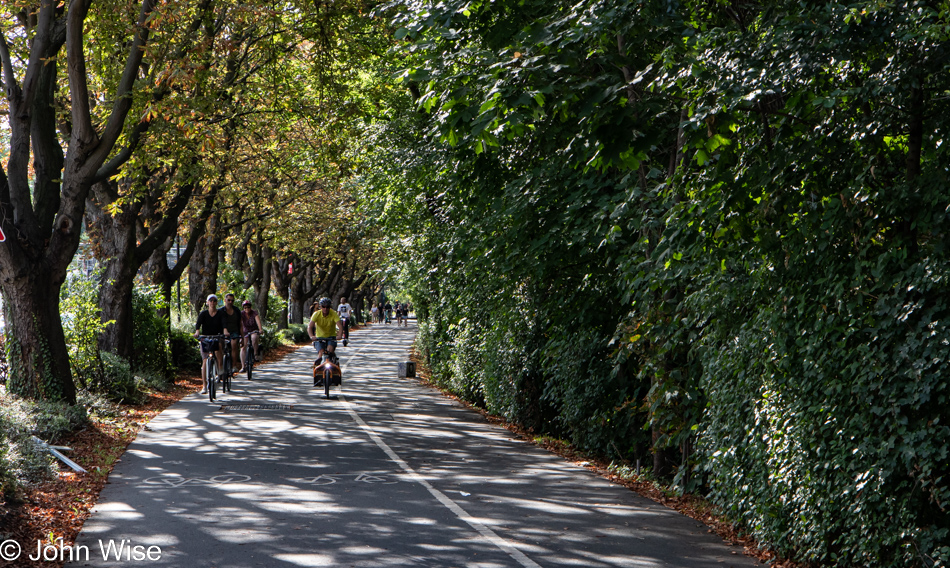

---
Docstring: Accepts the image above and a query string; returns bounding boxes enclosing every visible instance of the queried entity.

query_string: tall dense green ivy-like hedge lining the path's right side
[364,0,950,567]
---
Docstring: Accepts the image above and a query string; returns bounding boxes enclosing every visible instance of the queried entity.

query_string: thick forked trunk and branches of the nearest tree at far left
[0,0,154,404]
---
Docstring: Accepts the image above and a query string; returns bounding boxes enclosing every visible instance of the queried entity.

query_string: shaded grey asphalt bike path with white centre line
[64,320,759,568]
